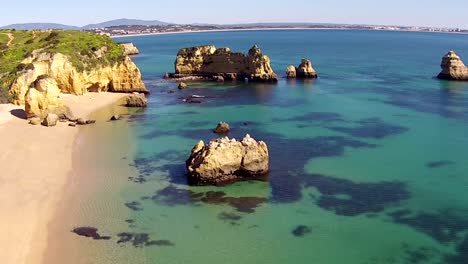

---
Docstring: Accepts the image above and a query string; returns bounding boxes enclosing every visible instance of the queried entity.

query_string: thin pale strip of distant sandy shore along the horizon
[110,27,468,39]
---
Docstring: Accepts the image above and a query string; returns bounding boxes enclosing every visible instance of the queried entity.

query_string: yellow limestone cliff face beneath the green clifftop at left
[10,51,148,105]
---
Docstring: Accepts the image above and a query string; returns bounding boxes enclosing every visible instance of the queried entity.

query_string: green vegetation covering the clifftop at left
[0,30,124,103]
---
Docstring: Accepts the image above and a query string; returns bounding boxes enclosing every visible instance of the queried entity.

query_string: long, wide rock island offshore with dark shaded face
[171,45,278,82]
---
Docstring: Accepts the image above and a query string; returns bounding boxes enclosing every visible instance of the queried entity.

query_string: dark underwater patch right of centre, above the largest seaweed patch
[329,118,408,139]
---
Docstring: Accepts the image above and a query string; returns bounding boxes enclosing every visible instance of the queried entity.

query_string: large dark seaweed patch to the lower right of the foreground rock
[304,174,410,216]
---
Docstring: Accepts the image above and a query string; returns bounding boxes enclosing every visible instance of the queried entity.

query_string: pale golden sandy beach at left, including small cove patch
[0,93,125,264]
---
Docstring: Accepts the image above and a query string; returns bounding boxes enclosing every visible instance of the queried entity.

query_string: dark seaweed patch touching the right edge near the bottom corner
[389,210,468,243]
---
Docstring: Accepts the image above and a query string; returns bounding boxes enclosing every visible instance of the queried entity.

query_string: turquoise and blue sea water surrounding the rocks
[63,31,468,264]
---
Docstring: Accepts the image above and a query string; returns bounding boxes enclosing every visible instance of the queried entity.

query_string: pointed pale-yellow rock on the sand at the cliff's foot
[24,76,73,120]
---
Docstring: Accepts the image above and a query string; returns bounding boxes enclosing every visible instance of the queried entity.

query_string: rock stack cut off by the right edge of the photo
[437,51,468,81]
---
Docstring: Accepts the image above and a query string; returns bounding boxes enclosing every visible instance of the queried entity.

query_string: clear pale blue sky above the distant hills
[0,0,468,29]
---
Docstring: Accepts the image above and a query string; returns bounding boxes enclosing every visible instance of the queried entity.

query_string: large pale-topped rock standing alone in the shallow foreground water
[186,135,269,185]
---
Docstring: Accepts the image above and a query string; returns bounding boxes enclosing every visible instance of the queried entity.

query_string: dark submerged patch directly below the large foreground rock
[152,186,267,213]
